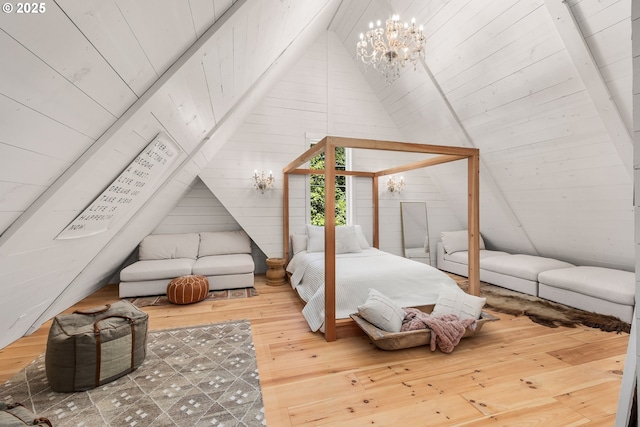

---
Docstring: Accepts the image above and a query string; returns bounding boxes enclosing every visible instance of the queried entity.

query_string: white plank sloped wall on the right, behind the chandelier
[332,0,635,270]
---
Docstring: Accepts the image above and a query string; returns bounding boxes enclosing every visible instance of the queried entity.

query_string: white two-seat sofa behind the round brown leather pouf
[119,230,255,298]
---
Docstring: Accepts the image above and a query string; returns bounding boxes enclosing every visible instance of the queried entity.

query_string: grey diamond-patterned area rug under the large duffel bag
[0,321,266,427]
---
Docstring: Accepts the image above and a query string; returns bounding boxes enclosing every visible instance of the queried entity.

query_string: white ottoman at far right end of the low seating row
[538,266,636,323]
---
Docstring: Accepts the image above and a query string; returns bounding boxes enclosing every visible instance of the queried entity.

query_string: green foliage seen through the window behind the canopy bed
[309,147,347,225]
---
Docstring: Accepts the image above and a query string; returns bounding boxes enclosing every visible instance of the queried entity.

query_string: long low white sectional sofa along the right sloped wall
[437,230,635,323]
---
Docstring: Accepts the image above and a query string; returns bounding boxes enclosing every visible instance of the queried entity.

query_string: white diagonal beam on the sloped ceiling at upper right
[545,0,633,176]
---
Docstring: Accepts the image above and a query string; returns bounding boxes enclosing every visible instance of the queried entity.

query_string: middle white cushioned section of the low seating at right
[480,254,573,296]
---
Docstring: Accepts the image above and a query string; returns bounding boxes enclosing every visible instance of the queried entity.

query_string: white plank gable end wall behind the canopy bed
[200,32,460,257]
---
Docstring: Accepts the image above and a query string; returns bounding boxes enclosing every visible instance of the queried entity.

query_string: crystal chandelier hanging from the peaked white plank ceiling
[356,15,425,83]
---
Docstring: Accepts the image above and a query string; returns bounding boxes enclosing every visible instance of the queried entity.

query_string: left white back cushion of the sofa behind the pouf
[138,233,200,261]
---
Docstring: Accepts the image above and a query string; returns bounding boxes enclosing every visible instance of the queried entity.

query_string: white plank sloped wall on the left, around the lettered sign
[0,0,337,347]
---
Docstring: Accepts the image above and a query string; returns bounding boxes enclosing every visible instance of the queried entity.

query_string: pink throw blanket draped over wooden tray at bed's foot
[400,307,476,353]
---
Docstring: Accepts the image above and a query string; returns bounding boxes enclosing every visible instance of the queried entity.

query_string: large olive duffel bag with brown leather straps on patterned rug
[45,301,149,392]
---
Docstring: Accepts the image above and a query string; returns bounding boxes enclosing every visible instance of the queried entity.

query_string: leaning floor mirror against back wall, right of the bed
[400,202,431,265]
